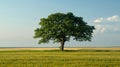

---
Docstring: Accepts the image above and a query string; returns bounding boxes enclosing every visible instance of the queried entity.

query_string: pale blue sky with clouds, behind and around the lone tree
[0,0,120,47]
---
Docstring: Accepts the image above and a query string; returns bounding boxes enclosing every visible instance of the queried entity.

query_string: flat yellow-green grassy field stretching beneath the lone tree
[0,48,120,67]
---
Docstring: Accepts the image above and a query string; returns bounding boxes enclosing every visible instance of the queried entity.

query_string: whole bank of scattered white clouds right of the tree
[93,15,120,33]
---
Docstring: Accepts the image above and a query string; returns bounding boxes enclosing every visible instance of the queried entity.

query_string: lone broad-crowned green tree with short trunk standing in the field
[34,12,95,50]
